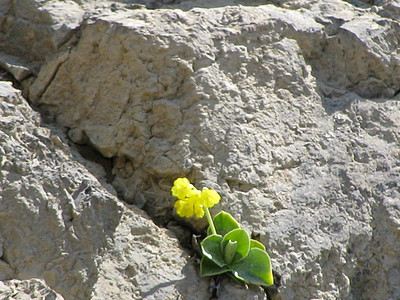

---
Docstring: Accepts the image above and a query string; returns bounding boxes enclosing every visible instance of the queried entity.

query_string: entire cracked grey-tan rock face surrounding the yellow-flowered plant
[0,0,400,299]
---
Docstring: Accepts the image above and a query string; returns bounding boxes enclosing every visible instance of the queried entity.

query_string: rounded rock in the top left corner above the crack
[0,0,85,63]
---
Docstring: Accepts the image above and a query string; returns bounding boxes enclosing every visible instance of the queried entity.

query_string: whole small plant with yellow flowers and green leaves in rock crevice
[171,178,274,286]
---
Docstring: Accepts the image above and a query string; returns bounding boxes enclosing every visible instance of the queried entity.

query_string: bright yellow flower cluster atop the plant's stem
[171,178,221,218]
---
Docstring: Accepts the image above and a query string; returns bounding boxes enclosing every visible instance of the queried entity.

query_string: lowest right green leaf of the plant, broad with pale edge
[230,248,274,286]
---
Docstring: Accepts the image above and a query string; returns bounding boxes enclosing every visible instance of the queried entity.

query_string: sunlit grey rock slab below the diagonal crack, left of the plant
[0,82,208,299]
